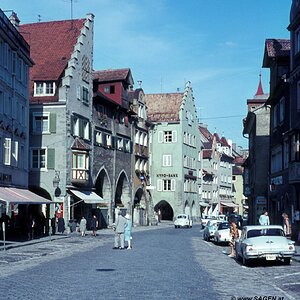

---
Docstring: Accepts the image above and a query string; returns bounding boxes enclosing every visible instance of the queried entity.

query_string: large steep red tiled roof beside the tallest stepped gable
[19,19,85,102]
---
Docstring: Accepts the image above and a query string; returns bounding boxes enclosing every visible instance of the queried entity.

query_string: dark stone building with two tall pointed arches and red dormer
[93,68,135,227]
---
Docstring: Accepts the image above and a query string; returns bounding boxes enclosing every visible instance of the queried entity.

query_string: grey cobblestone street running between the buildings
[0,223,300,299]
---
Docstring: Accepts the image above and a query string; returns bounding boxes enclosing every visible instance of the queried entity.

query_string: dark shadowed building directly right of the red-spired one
[263,39,292,224]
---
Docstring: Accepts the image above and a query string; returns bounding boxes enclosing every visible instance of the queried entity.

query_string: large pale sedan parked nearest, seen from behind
[235,225,296,265]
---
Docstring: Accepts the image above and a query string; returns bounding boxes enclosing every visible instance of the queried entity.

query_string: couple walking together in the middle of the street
[113,211,132,250]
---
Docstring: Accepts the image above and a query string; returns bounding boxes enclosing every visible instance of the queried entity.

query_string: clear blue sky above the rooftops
[0,0,292,149]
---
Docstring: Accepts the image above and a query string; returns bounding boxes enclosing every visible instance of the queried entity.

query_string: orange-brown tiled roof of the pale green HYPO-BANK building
[145,93,183,122]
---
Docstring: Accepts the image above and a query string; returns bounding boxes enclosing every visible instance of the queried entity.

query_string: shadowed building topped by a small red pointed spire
[243,78,270,224]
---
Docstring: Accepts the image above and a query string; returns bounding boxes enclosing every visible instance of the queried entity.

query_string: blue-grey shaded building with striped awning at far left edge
[0,9,50,234]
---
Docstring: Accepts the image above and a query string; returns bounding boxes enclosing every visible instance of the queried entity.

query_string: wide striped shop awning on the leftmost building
[0,187,53,204]
